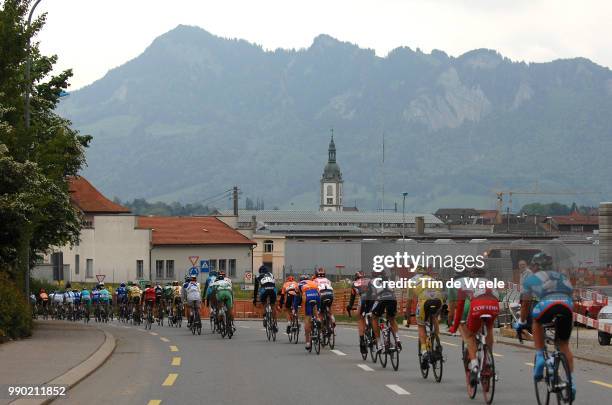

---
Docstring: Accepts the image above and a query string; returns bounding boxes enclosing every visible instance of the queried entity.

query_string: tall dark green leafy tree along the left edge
[0,0,91,288]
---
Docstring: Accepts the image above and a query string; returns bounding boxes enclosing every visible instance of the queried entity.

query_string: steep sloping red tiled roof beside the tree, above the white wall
[68,176,130,214]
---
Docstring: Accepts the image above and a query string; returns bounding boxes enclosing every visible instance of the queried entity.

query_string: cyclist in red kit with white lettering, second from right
[449,267,499,385]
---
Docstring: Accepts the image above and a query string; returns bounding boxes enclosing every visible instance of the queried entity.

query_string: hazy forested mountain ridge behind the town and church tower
[60,26,612,209]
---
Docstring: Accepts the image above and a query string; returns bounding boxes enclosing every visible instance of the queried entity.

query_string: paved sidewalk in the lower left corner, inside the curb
[0,320,106,405]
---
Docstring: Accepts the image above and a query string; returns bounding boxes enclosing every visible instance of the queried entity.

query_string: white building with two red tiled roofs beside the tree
[34,177,256,283]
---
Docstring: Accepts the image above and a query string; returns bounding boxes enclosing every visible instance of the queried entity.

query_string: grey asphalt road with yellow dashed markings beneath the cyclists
[57,321,612,405]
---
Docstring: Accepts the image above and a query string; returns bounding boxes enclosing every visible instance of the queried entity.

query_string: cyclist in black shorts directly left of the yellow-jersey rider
[368,270,402,352]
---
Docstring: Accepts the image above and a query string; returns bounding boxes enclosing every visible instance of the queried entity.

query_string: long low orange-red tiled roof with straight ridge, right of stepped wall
[138,217,255,245]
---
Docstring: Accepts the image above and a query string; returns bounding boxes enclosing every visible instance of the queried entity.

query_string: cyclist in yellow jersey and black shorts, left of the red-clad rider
[406,266,442,369]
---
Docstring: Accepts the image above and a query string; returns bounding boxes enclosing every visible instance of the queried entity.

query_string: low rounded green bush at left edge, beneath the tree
[0,273,32,341]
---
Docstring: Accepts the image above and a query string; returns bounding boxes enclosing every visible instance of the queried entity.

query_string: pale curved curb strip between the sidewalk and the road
[9,329,117,405]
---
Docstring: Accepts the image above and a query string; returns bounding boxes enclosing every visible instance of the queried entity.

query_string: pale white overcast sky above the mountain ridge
[37,0,612,90]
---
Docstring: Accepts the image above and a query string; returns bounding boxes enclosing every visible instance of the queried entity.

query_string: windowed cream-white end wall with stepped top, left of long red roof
[60,215,151,283]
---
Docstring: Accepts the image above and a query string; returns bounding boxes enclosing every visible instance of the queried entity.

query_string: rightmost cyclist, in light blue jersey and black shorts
[513,253,576,400]
